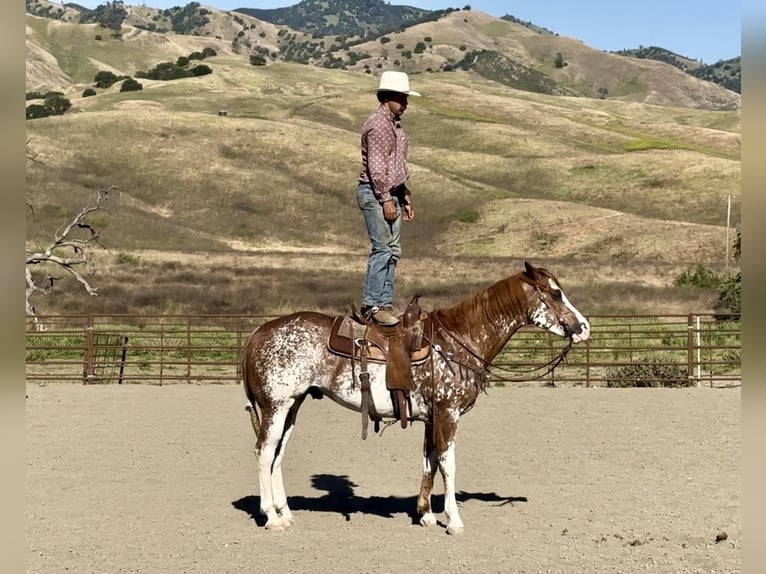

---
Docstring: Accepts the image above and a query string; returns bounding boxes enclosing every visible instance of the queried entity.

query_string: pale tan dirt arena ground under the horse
[26,384,742,574]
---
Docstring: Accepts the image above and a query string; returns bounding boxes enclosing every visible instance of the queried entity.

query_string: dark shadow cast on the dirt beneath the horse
[231,474,527,526]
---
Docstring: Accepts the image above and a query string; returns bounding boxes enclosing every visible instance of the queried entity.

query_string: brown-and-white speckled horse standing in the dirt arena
[241,262,590,534]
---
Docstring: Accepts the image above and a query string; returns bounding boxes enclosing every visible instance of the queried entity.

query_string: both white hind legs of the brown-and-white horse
[255,400,294,530]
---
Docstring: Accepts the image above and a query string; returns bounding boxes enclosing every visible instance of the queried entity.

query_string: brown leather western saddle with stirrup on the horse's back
[327,295,431,439]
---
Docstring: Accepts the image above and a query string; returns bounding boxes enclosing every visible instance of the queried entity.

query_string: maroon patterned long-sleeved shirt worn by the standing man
[359,105,409,203]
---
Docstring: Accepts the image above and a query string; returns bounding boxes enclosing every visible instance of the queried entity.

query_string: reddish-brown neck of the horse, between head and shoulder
[433,275,530,362]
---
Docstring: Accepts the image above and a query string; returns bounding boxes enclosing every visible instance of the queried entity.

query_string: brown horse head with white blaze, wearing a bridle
[520,261,590,343]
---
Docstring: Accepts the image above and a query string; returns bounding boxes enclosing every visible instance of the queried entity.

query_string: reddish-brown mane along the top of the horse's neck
[433,267,558,333]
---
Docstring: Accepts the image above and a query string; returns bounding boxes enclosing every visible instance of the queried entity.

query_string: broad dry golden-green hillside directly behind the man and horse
[27,17,741,320]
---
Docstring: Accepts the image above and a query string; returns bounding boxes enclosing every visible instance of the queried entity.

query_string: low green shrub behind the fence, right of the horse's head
[606,355,694,388]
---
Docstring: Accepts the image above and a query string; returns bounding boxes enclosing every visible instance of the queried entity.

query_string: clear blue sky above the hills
[69,0,748,64]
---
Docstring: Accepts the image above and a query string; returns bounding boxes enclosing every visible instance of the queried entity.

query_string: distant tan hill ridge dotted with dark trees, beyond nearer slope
[27,6,741,110]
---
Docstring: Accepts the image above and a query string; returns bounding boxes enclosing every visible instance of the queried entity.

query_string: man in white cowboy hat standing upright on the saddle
[356,71,420,326]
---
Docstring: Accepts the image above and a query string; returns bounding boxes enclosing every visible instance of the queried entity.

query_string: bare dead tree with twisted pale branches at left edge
[26,186,116,331]
